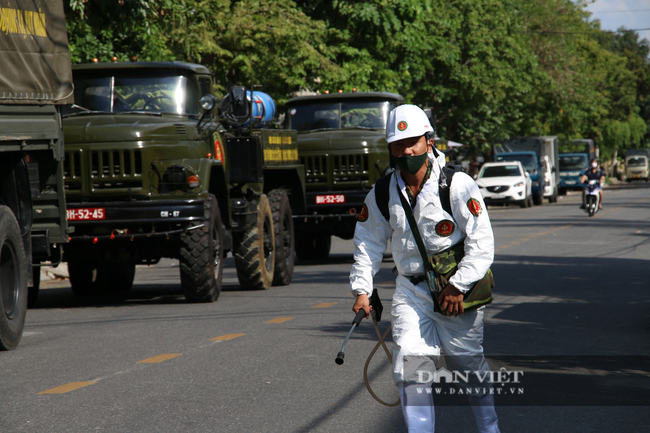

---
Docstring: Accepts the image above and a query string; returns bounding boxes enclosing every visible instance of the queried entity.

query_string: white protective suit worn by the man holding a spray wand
[350,152,499,432]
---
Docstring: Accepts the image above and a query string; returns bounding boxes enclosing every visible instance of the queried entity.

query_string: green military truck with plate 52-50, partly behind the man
[285,92,404,260]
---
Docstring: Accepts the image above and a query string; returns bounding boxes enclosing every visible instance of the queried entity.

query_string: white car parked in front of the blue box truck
[476,161,533,207]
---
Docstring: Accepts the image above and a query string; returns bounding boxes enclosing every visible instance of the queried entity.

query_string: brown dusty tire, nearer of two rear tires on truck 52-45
[233,195,275,290]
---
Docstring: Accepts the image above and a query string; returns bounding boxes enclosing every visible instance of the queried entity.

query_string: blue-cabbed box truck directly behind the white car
[493,136,559,205]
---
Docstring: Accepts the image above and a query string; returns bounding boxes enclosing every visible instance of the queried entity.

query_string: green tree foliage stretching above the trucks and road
[65,0,650,158]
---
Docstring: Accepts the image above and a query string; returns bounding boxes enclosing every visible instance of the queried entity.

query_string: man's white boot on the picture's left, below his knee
[399,382,436,433]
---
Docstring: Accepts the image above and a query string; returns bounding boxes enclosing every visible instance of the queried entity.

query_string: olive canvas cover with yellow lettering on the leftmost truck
[0,0,74,105]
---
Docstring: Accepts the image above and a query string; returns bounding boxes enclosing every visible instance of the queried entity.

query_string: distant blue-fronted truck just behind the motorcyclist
[560,139,596,195]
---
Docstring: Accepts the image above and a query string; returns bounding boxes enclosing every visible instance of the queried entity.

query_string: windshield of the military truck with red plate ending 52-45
[65,70,200,115]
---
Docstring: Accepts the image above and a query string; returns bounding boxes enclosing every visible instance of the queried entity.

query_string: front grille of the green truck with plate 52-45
[63,149,142,191]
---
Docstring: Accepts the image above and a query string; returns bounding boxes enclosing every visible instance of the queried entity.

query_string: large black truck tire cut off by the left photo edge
[0,206,28,350]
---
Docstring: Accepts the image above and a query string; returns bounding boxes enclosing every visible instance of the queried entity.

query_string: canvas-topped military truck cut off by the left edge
[0,0,72,350]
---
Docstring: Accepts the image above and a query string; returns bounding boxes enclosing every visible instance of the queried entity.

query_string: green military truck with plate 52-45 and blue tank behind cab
[63,62,304,302]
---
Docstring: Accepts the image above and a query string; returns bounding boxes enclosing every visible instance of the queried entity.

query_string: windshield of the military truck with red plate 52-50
[287,101,395,131]
